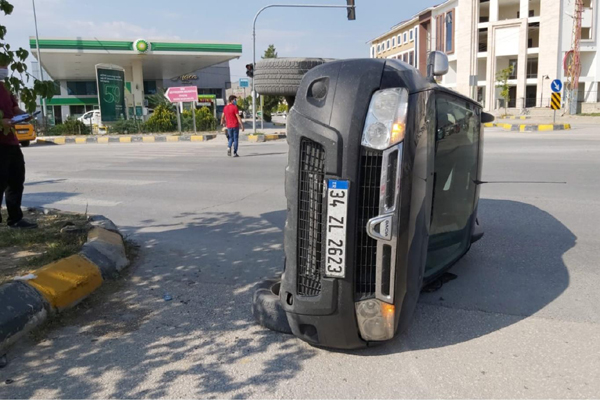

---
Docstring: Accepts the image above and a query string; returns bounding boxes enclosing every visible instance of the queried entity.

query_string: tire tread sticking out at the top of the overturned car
[254,58,332,97]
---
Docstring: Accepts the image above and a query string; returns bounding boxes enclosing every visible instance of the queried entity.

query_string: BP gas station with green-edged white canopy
[29,37,242,123]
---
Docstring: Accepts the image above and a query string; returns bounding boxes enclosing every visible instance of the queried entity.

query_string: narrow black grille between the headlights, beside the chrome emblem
[355,149,383,300]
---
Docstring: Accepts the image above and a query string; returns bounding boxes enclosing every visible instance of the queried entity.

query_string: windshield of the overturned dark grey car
[426,94,481,275]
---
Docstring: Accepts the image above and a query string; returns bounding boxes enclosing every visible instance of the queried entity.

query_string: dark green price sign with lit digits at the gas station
[96,64,126,122]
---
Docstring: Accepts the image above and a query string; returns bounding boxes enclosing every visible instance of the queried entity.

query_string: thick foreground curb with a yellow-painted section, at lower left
[0,209,129,355]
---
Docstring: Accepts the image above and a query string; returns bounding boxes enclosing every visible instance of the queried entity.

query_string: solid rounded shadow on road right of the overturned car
[358,199,577,355]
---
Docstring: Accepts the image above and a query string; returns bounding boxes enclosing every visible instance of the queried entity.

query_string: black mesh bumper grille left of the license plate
[297,139,325,296]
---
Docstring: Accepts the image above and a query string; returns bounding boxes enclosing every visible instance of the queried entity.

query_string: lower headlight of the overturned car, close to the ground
[356,299,395,341]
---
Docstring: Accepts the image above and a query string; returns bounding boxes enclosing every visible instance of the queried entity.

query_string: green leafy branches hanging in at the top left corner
[0,0,54,114]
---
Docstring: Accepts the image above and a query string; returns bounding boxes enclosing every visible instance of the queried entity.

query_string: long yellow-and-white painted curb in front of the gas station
[37,134,217,144]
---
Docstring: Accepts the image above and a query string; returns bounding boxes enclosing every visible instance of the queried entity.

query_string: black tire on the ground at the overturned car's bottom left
[252,279,292,334]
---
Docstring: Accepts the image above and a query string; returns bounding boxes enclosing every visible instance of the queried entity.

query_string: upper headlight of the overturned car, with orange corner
[362,88,408,150]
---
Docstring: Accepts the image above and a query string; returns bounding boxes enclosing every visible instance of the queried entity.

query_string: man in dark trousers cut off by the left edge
[0,65,37,229]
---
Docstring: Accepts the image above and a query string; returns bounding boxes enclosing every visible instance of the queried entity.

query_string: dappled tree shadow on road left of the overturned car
[0,211,317,398]
